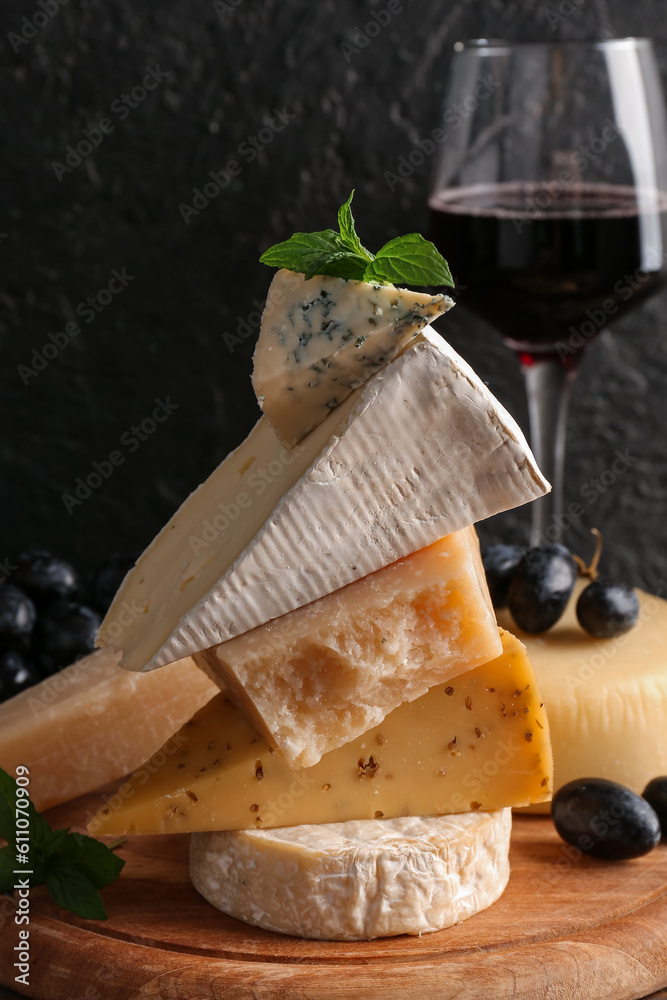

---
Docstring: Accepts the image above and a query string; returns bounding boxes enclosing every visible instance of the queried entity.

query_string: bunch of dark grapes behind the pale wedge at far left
[0,551,135,701]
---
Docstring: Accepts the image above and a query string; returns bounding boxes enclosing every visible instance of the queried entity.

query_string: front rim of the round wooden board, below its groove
[0,898,667,1000]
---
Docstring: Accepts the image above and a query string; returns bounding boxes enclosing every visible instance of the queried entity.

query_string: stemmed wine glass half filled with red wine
[429,38,667,545]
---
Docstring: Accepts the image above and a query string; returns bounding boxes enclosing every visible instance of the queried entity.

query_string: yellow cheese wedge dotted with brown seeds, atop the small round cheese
[89,633,551,834]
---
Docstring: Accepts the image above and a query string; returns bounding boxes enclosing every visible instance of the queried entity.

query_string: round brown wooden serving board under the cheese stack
[0,796,667,1000]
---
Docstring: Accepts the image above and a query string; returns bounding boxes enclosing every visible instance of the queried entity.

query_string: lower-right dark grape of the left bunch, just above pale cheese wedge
[35,601,101,673]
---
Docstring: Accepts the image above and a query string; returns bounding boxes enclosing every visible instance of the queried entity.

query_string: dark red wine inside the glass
[430,182,667,367]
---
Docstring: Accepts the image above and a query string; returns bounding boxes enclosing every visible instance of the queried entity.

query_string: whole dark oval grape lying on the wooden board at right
[551,778,660,861]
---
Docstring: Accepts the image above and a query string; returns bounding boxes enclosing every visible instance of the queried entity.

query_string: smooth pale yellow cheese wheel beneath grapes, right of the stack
[500,581,667,812]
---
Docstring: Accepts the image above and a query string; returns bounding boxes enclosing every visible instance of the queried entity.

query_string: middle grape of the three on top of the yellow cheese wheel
[507,545,577,633]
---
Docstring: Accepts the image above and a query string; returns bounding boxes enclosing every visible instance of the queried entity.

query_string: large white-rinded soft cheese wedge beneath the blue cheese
[98,330,548,670]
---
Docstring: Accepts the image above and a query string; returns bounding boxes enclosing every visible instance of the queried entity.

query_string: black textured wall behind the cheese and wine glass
[0,0,667,589]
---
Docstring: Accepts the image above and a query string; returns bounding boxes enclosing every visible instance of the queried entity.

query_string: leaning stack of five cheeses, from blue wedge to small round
[90,271,551,939]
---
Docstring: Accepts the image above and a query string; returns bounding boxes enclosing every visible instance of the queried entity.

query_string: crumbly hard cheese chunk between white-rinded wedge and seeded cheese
[195,527,502,767]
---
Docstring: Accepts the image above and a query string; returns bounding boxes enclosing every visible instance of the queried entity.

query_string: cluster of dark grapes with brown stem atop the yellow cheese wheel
[482,544,639,639]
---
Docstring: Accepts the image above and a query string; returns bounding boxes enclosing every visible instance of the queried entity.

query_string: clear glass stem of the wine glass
[522,358,576,545]
